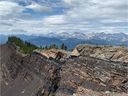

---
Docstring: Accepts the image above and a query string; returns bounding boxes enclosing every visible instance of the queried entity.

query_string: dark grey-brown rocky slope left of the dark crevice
[1,44,60,96]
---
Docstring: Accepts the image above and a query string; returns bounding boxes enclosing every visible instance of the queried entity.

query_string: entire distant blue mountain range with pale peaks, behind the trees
[0,32,128,49]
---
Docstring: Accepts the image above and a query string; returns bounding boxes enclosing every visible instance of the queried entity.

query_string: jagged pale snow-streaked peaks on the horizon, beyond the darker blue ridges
[47,32,128,41]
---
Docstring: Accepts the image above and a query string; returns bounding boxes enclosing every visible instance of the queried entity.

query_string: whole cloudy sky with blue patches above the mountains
[0,0,128,35]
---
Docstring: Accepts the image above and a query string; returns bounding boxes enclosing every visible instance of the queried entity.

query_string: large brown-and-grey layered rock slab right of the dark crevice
[57,56,128,96]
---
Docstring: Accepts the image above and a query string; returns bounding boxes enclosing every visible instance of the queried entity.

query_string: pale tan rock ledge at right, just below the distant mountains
[73,44,128,63]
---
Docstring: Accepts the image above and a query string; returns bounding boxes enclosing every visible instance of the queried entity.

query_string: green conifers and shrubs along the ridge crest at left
[7,36,67,54]
